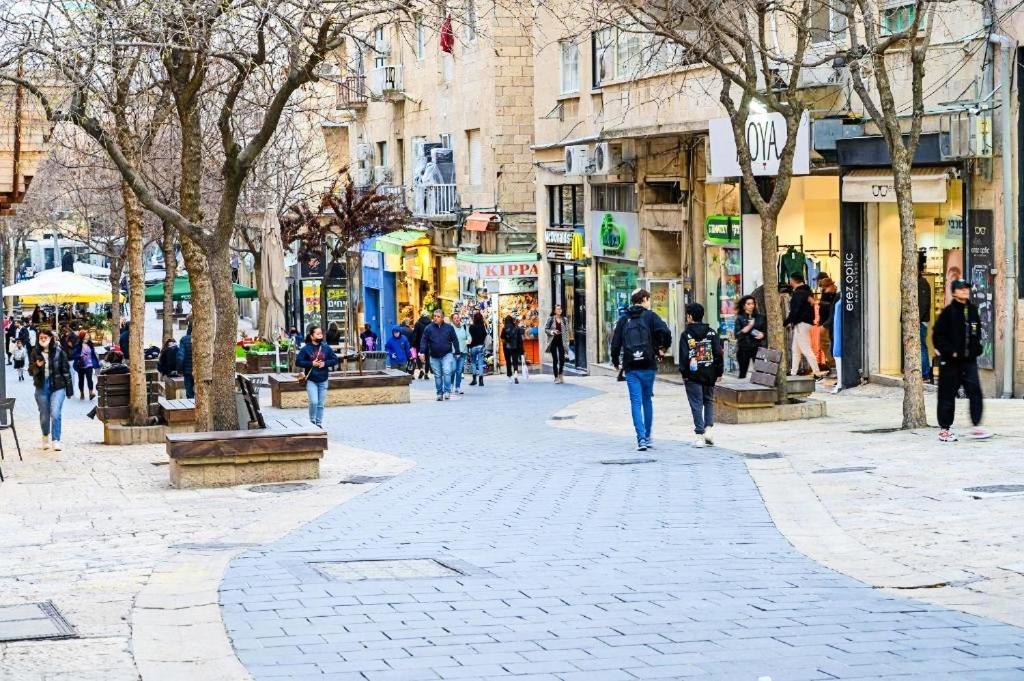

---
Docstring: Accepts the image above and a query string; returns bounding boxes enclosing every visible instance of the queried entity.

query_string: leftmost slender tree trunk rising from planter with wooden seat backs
[121,182,150,426]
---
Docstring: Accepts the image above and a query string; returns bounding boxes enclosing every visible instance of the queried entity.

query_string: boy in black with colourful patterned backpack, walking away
[679,303,725,448]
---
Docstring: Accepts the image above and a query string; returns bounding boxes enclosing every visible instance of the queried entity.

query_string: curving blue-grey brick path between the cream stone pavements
[221,381,1024,681]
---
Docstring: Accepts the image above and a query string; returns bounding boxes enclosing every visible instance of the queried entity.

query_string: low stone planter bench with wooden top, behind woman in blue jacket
[267,369,413,409]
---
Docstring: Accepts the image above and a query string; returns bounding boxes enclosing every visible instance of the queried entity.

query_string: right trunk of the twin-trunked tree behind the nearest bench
[208,243,239,430]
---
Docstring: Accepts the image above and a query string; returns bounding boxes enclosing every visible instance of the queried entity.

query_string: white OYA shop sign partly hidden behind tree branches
[708,112,811,177]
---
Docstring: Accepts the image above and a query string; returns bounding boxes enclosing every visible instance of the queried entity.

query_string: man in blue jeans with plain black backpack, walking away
[611,289,672,452]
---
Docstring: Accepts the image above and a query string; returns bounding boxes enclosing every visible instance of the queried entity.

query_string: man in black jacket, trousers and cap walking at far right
[932,279,992,442]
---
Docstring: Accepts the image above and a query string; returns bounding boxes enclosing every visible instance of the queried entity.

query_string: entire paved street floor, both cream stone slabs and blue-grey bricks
[0,364,1024,681]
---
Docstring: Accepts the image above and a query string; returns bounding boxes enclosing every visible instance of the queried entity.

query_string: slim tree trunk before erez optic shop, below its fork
[892,144,928,428]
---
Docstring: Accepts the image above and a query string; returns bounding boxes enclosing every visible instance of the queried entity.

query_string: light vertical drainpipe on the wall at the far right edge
[988,34,1017,398]
